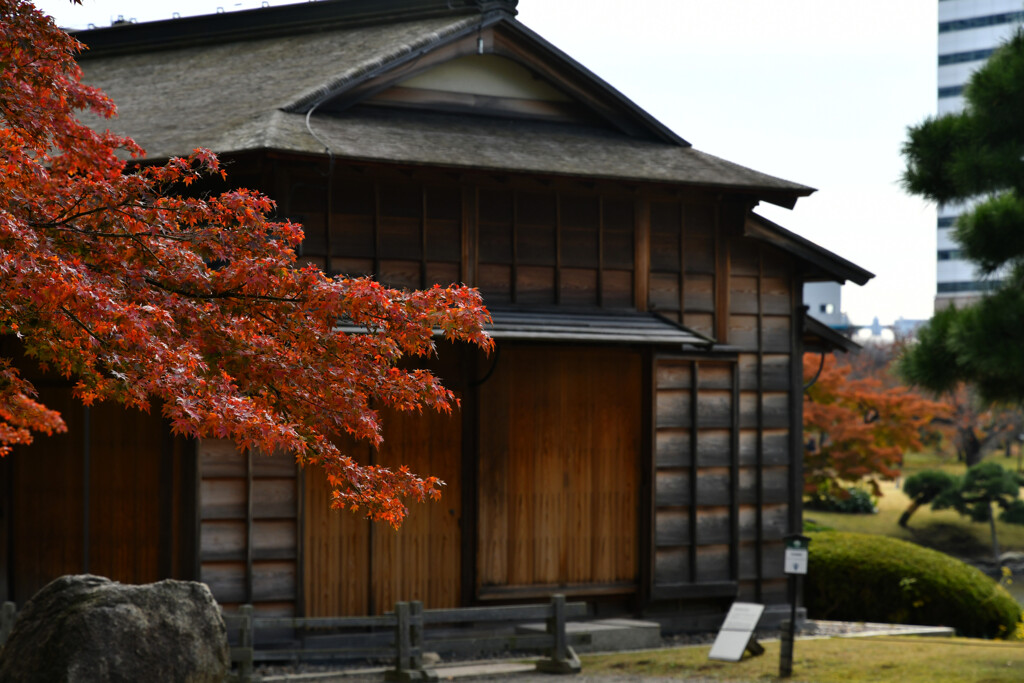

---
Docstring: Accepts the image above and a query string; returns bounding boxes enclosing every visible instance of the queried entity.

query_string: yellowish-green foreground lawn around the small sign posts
[582,636,1024,683]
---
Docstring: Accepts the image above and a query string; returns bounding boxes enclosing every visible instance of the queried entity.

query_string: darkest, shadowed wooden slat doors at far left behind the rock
[8,388,169,604]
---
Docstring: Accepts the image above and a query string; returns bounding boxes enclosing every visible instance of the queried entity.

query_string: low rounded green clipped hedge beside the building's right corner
[805,531,1021,638]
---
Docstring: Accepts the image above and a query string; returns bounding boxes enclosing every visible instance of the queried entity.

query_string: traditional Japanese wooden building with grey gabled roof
[0,0,871,627]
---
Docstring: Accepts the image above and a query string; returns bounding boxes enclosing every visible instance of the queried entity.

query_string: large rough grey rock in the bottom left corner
[0,574,230,683]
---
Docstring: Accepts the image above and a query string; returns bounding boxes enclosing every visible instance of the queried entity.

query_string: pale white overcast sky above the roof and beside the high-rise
[36,0,937,325]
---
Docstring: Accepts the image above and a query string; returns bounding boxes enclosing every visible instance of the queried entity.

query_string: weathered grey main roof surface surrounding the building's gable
[82,16,812,196]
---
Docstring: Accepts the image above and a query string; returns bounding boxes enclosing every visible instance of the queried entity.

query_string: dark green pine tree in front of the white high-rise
[901,32,1024,402]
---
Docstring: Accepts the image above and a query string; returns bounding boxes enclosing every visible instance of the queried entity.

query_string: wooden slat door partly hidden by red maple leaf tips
[303,403,462,616]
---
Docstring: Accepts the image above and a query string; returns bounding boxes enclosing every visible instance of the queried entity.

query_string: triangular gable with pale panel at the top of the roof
[285,13,689,146]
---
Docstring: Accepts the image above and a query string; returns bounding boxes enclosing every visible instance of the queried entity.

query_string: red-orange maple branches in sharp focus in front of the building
[0,0,492,524]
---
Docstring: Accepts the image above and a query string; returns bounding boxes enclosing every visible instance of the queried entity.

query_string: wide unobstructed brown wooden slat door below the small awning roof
[477,346,641,598]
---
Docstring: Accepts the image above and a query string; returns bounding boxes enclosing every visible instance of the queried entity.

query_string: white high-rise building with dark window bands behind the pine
[935,0,1024,309]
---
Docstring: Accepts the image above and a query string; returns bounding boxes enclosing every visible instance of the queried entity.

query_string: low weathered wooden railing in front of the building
[224,595,590,683]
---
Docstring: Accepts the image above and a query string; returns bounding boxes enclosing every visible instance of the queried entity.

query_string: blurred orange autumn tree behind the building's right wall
[804,353,950,495]
